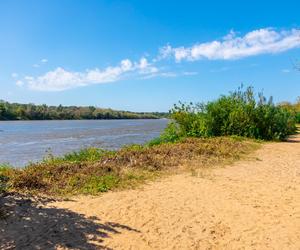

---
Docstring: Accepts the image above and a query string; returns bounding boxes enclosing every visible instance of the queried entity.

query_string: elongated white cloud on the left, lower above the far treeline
[24,58,158,91]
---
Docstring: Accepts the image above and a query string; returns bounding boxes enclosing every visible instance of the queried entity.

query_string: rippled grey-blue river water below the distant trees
[0,119,168,167]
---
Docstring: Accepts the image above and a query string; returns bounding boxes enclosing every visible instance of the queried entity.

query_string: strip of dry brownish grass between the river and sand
[2,137,255,195]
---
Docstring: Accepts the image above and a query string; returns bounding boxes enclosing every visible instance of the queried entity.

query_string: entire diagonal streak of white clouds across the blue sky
[19,28,300,91]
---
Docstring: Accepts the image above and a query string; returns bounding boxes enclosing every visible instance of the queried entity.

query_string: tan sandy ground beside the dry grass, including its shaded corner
[0,136,300,249]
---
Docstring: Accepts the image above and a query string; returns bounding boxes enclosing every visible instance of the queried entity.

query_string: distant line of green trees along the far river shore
[0,101,168,120]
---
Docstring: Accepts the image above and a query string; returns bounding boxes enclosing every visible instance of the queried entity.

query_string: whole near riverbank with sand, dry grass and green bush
[0,88,300,249]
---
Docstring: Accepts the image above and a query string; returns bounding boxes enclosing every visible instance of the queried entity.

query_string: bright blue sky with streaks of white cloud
[0,0,300,111]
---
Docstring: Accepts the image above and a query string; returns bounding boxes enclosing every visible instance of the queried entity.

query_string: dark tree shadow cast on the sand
[0,194,139,250]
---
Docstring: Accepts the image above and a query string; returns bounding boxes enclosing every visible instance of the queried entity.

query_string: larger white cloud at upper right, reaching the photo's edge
[159,28,300,62]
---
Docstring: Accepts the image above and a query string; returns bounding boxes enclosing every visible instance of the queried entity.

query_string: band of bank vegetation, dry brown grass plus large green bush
[0,88,296,195]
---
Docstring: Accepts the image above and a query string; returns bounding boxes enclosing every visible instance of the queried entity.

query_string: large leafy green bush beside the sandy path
[165,87,296,140]
